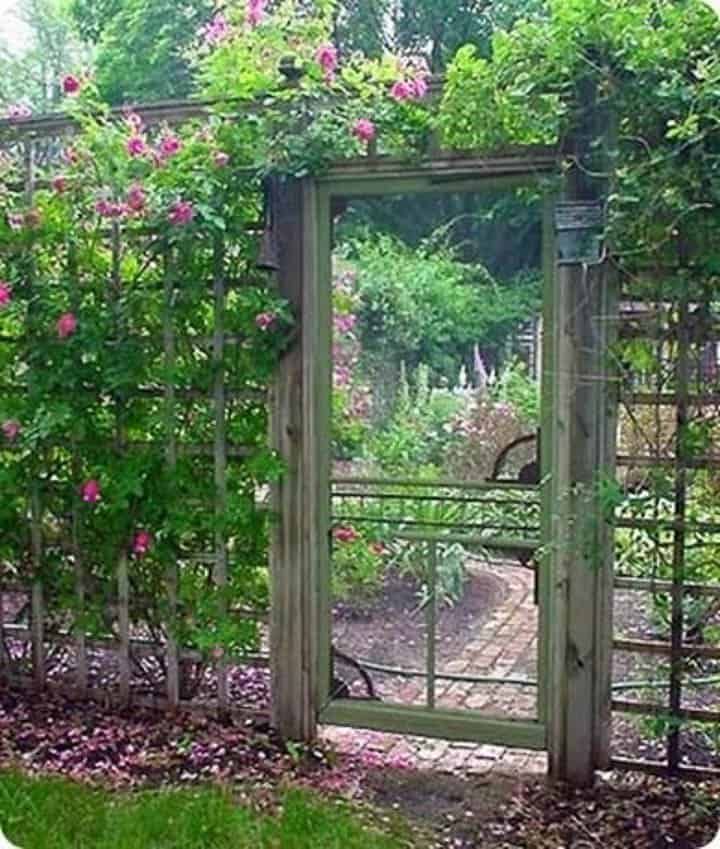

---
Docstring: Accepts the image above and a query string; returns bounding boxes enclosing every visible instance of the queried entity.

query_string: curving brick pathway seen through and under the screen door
[323,560,547,775]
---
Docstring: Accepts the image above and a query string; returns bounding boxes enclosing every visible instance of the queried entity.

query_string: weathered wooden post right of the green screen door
[549,78,617,785]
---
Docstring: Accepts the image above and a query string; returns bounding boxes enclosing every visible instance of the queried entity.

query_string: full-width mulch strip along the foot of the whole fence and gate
[0,690,720,849]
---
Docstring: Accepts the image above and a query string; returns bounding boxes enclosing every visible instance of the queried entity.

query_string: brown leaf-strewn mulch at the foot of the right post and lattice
[369,770,720,849]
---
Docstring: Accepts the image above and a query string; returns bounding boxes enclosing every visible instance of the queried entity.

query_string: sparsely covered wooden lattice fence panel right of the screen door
[613,276,720,775]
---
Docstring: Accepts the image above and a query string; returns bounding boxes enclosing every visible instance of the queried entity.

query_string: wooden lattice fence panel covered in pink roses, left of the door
[0,113,283,711]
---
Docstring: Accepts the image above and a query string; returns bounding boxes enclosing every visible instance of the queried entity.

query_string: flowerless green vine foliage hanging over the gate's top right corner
[440,0,720,272]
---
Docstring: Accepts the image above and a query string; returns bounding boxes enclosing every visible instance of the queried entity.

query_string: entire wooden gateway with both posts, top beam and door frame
[271,142,616,784]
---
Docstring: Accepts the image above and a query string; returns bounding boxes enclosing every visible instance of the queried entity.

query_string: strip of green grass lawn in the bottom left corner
[0,772,408,849]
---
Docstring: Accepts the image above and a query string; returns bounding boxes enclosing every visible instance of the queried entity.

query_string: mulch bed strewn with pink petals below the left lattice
[0,690,348,790]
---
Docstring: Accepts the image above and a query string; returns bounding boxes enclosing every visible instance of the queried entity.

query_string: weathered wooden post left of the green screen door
[270,180,330,741]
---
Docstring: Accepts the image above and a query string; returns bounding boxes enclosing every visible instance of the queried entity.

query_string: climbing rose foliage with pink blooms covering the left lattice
[0,89,292,653]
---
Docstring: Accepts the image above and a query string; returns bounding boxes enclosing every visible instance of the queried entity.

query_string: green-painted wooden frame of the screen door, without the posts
[313,159,555,750]
